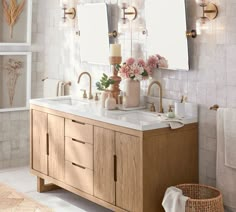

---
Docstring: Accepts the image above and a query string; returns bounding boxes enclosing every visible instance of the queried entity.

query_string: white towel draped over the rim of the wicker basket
[162,186,189,212]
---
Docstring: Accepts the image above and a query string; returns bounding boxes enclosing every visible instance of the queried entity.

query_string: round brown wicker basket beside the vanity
[176,184,224,212]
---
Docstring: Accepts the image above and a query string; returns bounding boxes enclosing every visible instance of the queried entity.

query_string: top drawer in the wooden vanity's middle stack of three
[65,119,93,144]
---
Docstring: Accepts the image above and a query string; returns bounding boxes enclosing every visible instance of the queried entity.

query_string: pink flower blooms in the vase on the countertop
[116,55,168,81]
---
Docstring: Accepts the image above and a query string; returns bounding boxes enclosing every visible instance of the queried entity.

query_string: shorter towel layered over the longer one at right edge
[223,108,236,169]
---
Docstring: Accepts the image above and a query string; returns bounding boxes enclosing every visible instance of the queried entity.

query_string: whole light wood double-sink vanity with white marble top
[30,97,198,212]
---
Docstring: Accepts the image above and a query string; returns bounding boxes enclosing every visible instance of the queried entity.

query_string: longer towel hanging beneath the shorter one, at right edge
[216,108,236,211]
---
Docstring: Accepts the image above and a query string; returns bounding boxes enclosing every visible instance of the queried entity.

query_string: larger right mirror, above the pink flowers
[145,0,189,71]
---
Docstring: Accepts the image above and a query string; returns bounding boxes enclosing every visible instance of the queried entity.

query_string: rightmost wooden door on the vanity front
[116,133,142,212]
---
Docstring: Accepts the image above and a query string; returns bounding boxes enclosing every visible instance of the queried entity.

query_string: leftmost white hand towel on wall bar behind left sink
[43,79,60,98]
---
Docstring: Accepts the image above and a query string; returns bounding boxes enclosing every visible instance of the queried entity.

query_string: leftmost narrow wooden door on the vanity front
[31,110,48,175]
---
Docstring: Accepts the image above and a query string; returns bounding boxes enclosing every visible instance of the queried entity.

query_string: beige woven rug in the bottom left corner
[0,183,53,212]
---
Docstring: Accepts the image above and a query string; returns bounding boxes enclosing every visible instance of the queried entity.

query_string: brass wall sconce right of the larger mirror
[196,0,218,34]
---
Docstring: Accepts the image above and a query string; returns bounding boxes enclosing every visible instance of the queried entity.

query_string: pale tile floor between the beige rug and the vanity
[0,167,111,212]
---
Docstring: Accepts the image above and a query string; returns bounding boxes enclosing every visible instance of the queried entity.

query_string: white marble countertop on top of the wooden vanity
[30,96,198,131]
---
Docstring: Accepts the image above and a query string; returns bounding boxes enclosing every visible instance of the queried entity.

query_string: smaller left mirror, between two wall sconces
[77,3,109,65]
